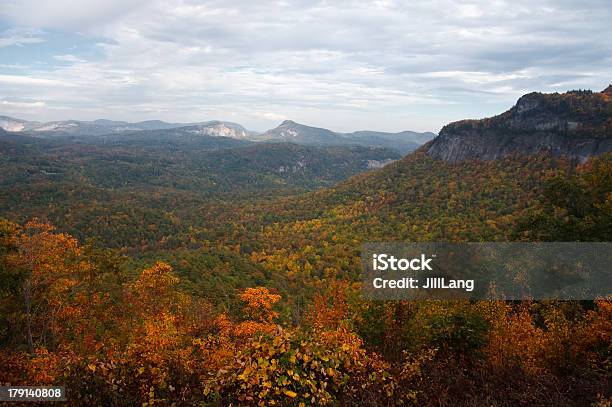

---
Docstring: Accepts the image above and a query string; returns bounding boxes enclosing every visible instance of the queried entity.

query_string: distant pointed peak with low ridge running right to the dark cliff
[257,120,435,154]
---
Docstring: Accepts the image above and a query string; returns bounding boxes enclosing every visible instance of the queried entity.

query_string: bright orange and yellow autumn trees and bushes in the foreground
[0,222,612,406]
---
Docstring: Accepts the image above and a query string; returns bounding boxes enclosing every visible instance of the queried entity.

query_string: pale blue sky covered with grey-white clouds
[0,0,612,132]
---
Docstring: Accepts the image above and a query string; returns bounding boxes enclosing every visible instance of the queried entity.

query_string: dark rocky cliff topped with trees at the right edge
[426,86,612,163]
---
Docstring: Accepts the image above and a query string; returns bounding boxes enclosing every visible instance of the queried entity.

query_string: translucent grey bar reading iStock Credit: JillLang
[361,242,612,300]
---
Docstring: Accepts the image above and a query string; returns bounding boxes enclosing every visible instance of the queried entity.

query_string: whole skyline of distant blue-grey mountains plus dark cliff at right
[0,85,612,167]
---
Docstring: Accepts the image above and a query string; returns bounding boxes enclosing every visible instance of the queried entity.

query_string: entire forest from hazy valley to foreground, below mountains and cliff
[0,92,612,406]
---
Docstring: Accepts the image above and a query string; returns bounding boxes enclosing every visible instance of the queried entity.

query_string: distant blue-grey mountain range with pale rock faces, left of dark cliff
[0,116,435,154]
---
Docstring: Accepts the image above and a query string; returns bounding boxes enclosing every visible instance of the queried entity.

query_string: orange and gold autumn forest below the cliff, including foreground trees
[0,143,612,406]
